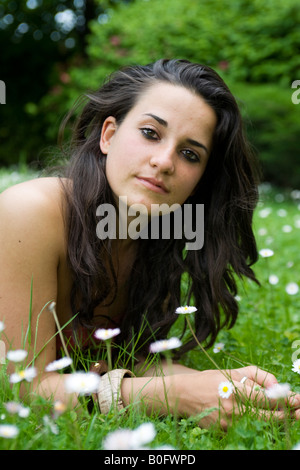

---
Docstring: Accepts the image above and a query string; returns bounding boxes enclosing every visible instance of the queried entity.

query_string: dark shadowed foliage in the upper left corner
[0,0,125,166]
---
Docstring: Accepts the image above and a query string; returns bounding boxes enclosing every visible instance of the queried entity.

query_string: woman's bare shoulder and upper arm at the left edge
[0,179,62,382]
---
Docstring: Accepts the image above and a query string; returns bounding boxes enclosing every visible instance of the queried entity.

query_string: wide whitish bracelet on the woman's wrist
[97,369,135,414]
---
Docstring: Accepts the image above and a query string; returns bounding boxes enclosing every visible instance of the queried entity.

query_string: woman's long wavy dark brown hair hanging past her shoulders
[59,59,259,357]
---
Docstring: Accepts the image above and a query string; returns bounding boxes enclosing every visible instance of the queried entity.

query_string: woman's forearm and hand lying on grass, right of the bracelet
[122,366,300,429]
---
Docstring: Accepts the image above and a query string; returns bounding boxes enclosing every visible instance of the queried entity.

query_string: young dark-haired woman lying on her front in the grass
[0,60,300,426]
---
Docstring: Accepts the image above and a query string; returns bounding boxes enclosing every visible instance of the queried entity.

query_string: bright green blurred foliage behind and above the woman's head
[0,0,300,187]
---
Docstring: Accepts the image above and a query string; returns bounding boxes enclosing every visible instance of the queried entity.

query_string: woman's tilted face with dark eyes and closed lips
[100,82,216,214]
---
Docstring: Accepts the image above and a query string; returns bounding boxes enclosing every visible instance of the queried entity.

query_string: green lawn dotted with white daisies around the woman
[0,169,300,450]
